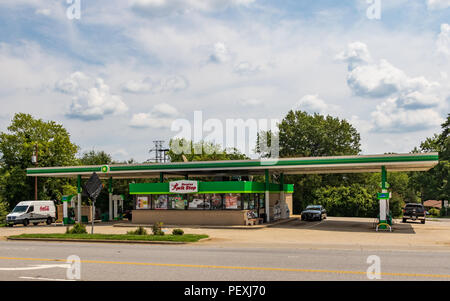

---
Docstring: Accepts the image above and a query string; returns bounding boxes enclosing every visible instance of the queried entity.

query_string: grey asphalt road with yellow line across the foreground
[0,241,450,281]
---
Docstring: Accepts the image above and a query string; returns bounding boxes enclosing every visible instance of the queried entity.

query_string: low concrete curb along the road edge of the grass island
[7,237,211,245]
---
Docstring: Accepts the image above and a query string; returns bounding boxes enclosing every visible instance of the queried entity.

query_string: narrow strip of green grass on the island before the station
[9,233,209,242]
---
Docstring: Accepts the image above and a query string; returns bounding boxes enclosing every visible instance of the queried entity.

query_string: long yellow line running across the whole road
[0,257,450,279]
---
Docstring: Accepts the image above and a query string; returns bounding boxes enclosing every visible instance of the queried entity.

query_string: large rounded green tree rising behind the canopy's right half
[256,110,365,213]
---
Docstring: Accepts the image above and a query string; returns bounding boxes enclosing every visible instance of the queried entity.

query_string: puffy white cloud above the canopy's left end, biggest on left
[55,72,128,120]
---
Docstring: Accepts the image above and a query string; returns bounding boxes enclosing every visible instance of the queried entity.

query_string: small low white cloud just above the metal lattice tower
[129,103,180,129]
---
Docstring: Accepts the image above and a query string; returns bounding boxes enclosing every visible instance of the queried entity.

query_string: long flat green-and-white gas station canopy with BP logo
[27,153,439,179]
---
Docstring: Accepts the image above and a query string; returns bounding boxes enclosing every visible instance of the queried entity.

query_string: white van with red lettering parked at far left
[6,201,57,226]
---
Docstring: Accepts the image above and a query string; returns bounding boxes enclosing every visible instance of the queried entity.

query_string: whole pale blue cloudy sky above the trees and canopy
[0,0,450,161]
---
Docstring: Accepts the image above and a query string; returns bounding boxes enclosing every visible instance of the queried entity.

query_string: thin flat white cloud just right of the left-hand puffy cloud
[122,75,189,94]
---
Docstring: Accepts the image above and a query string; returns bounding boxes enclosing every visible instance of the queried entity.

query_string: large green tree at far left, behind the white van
[0,113,78,208]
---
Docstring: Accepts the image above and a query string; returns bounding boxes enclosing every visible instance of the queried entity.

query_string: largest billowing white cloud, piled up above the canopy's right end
[337,42,448,133]
